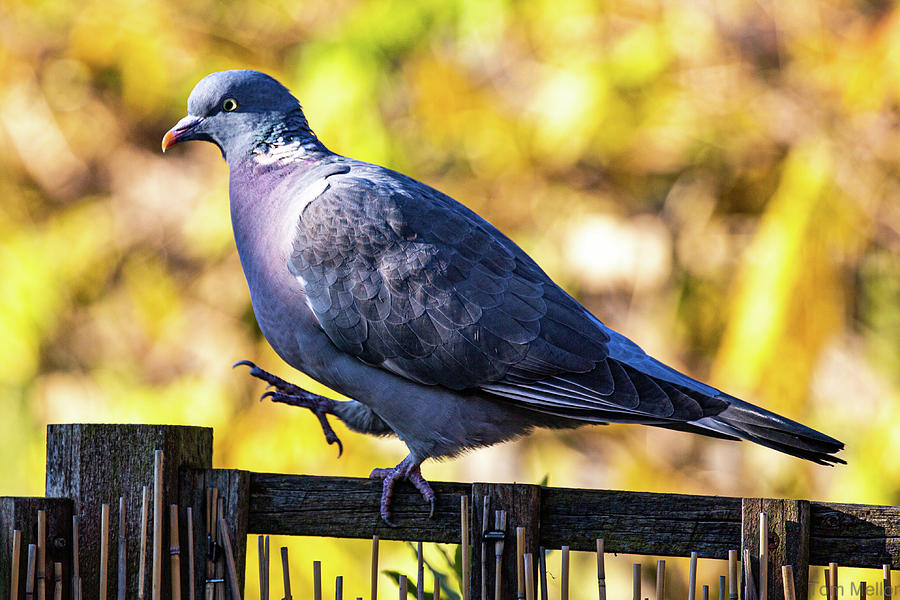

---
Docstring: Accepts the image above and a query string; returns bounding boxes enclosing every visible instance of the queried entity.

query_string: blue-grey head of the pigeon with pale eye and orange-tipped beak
[162,70,300,160]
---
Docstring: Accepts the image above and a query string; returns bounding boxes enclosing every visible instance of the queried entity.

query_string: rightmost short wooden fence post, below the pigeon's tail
[741,498,810,600]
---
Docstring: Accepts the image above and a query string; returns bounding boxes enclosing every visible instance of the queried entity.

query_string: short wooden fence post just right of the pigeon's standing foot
[469,483,541,600]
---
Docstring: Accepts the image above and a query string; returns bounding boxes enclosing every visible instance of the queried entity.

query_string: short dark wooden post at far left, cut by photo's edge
[0,497,72,600]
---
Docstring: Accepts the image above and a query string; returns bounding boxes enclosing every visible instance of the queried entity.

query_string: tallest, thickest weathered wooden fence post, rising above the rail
[46,424,212,598]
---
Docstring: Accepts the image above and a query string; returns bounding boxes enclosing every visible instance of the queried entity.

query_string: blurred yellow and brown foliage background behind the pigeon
[0,0,900,598]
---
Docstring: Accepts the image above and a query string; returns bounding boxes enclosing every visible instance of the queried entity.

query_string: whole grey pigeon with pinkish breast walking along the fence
[162,70,845,524]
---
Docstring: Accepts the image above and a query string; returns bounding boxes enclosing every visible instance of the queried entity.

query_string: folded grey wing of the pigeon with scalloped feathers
[289,170,725,425]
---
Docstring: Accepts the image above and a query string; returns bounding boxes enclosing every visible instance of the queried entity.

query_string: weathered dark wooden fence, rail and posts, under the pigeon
[0,425,900,600]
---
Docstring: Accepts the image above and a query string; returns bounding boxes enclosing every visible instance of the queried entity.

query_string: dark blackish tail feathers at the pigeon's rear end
[691,394,847,465]
